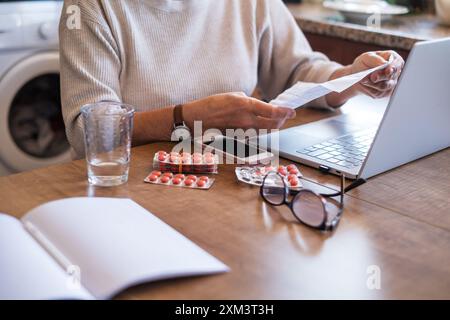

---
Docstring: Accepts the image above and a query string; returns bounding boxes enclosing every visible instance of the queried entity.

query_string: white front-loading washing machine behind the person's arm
[0,0,70,175]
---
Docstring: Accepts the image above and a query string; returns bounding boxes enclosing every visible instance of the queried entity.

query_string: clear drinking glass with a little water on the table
[81,102,135,187]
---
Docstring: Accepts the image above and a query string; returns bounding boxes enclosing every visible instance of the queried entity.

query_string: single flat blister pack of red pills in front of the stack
[144,171,215,190]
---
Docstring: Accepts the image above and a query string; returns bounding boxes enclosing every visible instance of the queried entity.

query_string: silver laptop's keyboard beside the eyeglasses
[297,130,376,169]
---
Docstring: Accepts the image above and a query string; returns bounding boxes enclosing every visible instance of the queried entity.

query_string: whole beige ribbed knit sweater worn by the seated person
[60,0,339,158]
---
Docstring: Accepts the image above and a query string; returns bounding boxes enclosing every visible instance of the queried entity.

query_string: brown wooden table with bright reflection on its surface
[0,98,450,299]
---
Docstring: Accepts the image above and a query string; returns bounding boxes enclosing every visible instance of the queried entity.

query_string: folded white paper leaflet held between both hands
[270,56,394,109]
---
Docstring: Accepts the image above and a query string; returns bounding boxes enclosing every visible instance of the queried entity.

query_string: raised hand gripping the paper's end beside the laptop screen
[351,51,405,98]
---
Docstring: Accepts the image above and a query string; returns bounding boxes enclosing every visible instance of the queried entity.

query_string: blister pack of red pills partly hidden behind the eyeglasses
[235,164,303,189]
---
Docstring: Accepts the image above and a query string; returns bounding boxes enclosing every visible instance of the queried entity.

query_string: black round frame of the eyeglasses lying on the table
[260,171,346,232]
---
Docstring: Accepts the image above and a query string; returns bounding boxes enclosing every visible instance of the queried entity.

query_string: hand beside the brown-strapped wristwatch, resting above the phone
[183,93,296,130]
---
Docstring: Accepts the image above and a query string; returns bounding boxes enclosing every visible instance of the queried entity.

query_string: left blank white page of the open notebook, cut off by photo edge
[0,214,93,300]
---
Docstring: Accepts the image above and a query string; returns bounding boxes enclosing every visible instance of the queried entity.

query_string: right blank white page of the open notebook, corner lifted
[24,198,228,299]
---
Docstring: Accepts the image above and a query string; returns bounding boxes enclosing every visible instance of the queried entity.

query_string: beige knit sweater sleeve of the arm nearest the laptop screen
[257,0,341,107]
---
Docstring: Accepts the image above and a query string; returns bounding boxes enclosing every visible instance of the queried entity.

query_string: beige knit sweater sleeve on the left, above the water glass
[59,1,121,158]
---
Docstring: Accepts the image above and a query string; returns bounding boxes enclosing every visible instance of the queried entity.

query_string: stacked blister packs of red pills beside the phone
[153,151,219,174]
